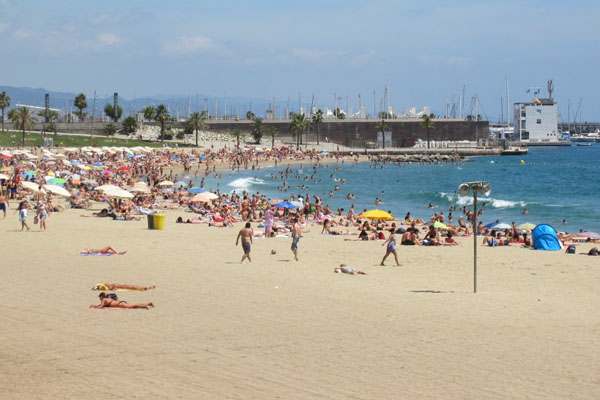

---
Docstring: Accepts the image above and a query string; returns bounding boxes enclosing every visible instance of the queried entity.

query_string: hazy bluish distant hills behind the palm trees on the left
[0,85,282,118]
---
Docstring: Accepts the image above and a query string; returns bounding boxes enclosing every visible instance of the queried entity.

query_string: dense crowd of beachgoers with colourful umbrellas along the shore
[0,146,596,308]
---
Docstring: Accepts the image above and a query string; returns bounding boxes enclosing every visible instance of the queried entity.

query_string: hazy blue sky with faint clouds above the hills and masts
[0,0,600,121]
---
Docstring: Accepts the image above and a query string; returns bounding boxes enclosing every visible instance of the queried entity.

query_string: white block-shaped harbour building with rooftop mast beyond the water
[514,98,561,141]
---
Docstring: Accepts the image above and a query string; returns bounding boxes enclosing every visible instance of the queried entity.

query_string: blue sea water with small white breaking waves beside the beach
[191,144,600,232]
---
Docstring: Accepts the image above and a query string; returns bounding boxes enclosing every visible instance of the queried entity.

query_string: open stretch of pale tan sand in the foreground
[0,203,600,399]
